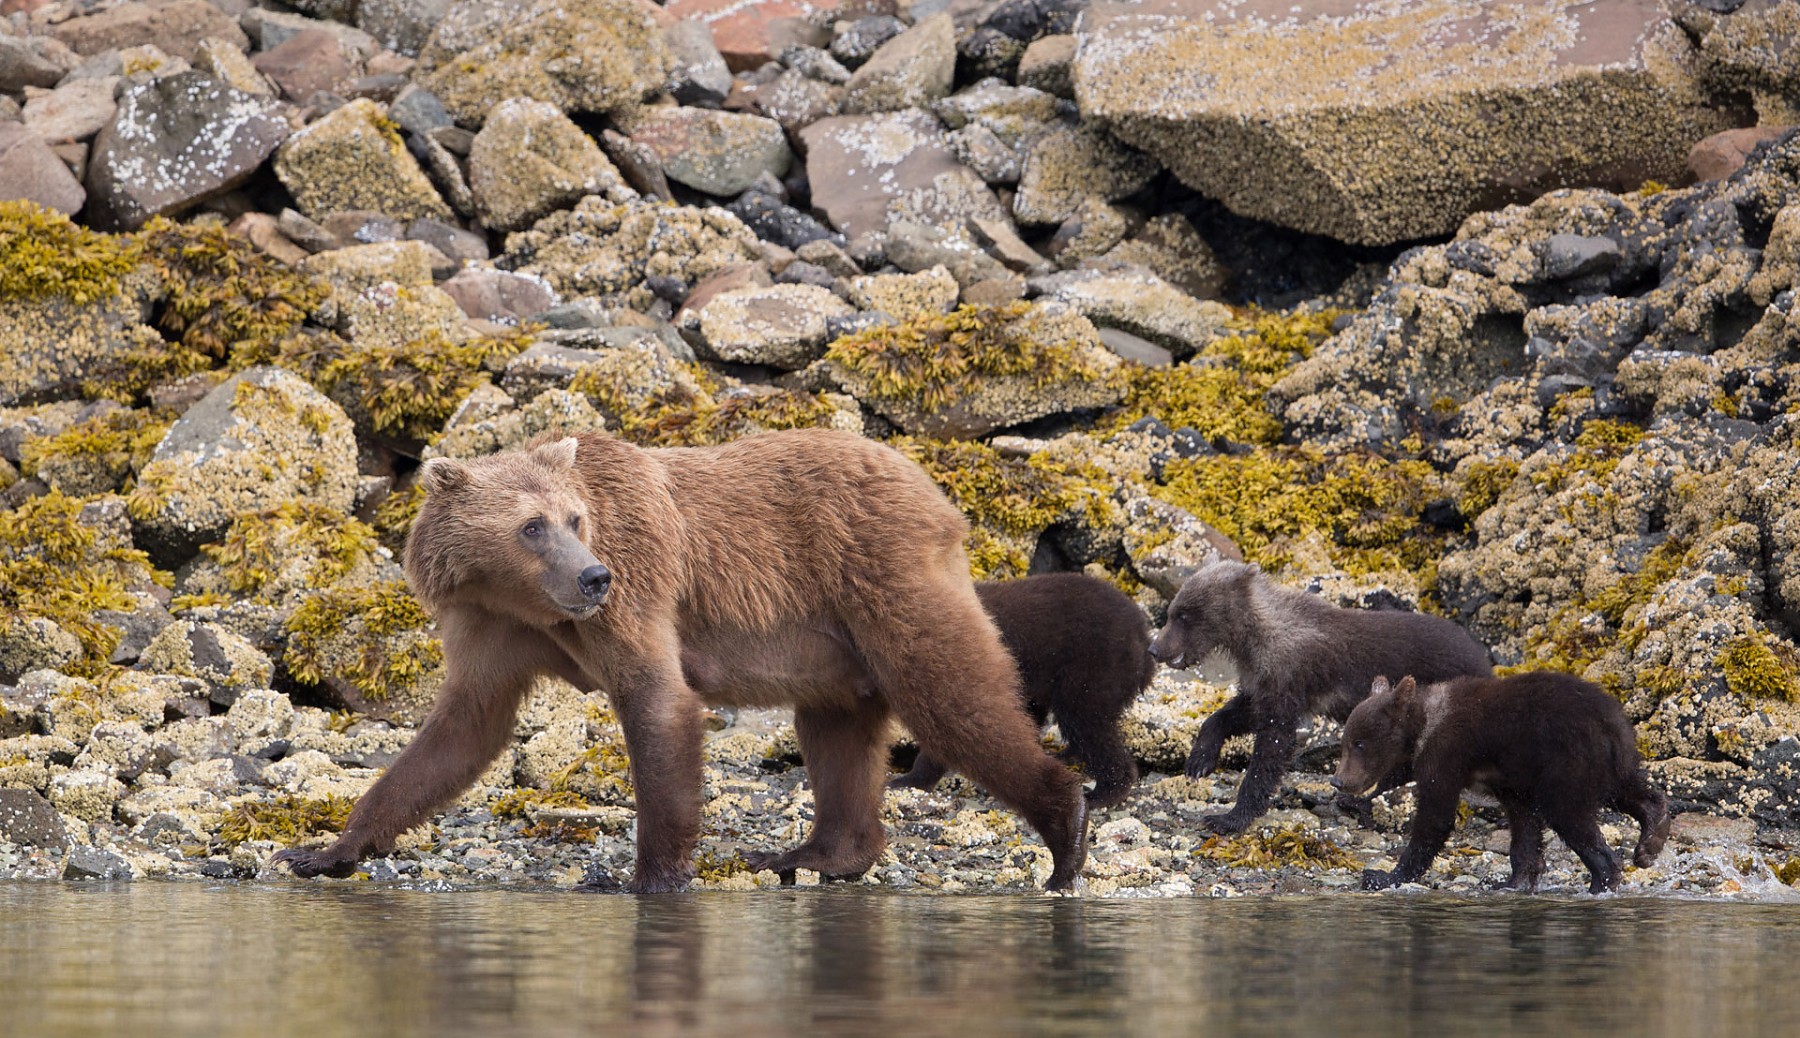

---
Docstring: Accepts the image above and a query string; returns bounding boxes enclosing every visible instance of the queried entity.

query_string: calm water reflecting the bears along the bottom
[0,883,1800,1038]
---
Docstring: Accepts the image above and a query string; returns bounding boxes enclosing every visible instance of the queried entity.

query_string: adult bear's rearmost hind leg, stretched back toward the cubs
[846,550,1087,889]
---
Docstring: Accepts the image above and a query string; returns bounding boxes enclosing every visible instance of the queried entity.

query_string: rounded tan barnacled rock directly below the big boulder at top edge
[468,97,630,230]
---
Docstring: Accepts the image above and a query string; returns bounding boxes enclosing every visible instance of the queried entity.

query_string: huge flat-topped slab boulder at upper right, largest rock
[1075,0,1742,245]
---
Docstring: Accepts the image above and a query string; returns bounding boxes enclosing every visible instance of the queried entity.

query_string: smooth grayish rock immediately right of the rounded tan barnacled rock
[623,108,794,196]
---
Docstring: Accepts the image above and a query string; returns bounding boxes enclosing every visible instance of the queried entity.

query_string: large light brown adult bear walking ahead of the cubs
[264,430,1087,892]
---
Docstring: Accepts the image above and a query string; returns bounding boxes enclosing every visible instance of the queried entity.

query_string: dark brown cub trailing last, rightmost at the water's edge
[1332,671,1669,894]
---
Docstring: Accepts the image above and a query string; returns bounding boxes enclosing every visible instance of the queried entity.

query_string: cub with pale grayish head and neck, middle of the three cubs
[1150,561,1492,833]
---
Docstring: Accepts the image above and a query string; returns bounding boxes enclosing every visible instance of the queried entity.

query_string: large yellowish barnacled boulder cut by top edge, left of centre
[419,0,670,126]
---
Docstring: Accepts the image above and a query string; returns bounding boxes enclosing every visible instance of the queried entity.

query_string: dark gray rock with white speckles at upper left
[88,72,288,230]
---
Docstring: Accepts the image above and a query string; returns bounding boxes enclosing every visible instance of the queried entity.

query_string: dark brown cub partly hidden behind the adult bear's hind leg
[889,574,1156,808]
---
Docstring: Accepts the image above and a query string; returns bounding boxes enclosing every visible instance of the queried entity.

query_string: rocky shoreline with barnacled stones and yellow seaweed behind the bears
[0,0,1800,898]
